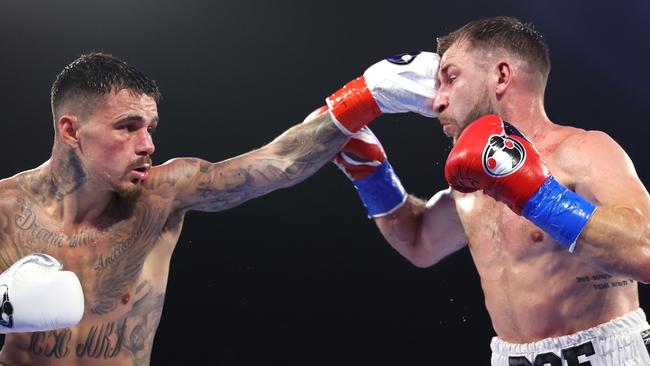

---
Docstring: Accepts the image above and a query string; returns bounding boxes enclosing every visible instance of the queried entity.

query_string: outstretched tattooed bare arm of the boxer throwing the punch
[149,113,348,212]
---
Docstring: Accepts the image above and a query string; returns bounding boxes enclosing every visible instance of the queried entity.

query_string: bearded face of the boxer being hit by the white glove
[434,41,496,143]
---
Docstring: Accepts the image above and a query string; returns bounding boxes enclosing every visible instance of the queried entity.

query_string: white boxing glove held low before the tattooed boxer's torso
[0,253,84,333]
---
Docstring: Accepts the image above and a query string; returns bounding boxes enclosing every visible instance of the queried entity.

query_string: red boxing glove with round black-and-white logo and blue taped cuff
[445,115,596,252]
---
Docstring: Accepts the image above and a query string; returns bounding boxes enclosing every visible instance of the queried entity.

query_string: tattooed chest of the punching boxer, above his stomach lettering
[0,197,180,316]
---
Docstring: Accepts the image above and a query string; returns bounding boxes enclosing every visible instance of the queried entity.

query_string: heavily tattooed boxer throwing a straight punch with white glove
[0,53,435,365]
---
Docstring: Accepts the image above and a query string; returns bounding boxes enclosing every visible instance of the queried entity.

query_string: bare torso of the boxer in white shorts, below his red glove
[454,126,639,343]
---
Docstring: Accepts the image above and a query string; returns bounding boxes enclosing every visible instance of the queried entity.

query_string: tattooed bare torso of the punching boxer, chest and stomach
[0,171,183,365]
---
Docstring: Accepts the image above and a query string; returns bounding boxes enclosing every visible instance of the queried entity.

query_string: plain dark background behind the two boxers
[0,0,650,365]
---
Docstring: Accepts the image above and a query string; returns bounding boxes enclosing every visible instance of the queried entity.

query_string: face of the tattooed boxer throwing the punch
[77,89,158,197]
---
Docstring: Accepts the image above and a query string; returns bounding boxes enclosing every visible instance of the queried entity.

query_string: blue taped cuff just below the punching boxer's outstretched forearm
[353,160,406,217]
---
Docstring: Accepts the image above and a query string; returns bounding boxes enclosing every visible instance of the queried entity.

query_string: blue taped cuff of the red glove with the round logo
[522,176,597,253]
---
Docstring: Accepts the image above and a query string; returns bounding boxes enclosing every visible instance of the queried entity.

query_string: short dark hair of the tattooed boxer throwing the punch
[50,52,161,118]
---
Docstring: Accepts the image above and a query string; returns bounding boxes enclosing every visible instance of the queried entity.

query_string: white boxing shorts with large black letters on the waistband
[490,309,650,366]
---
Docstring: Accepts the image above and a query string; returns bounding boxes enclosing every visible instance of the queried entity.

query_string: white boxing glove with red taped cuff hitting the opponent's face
[326,52,440,135]
